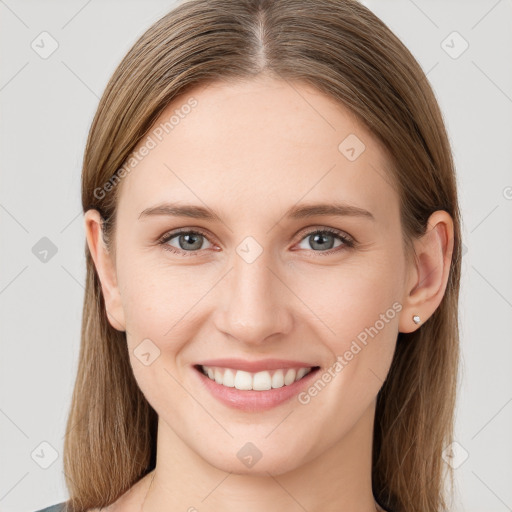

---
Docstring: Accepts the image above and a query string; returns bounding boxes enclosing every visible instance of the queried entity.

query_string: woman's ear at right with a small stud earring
[398,210,454,333]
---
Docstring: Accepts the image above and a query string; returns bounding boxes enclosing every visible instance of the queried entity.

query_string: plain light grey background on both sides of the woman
[0,0,512,512]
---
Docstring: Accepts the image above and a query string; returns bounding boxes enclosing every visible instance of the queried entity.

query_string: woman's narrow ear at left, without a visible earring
[84,209,126,331]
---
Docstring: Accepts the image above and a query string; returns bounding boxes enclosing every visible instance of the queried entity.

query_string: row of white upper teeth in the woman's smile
[201,366,311,391]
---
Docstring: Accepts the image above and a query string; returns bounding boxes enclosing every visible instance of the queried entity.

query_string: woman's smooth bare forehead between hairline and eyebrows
[119,78,398,226]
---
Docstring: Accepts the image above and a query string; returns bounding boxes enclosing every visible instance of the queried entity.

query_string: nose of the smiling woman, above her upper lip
[215,251,293,345]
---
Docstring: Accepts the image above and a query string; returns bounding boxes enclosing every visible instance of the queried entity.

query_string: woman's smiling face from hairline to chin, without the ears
[90,78,414,474]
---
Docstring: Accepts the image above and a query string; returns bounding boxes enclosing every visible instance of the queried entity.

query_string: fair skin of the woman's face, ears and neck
[85,76,453,512]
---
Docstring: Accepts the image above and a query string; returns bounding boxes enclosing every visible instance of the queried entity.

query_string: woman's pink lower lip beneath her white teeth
[193,367,319,412]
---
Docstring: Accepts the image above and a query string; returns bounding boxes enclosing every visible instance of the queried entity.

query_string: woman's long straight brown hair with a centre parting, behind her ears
[64,0,461,512]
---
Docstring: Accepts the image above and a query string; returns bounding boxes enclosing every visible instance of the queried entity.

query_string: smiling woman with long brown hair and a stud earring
[35,0,461,512]
